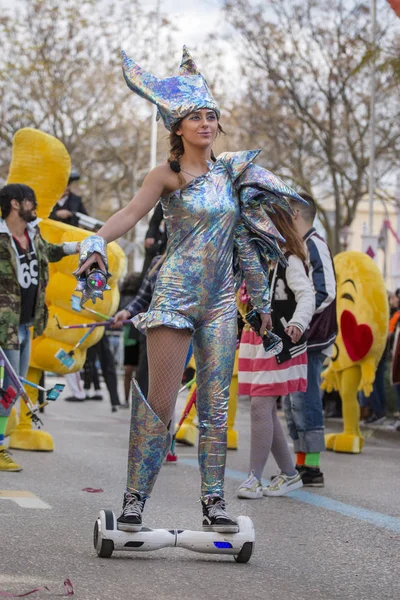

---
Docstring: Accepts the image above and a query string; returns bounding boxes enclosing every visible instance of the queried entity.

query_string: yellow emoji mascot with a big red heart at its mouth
[321,252,389,454]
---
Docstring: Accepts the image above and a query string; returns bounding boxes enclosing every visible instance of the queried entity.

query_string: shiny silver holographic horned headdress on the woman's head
[122,46,220,131]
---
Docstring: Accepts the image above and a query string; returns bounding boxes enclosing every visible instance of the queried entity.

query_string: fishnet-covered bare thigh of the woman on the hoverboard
[147,327,192,426]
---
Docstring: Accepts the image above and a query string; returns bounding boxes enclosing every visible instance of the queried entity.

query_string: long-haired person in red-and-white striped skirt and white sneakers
[237,209,315,499]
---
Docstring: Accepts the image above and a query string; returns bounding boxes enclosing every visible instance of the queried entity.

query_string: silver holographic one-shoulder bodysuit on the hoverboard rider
[128,152,278,496]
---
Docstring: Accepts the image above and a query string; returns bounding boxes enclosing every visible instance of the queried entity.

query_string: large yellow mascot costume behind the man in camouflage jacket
[6,128,126,451]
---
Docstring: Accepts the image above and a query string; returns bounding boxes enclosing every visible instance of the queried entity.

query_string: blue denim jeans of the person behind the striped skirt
[283,352,326,452]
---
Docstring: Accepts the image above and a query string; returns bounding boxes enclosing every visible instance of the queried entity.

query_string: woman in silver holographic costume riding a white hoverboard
[77,48,301,532]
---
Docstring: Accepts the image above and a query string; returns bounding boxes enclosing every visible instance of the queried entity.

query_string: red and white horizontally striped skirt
[238,328,307,396]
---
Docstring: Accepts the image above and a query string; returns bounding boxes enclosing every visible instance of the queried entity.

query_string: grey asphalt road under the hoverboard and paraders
[0,380,400,600]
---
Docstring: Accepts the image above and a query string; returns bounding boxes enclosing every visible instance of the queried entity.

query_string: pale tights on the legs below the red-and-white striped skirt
[249,396,296,480]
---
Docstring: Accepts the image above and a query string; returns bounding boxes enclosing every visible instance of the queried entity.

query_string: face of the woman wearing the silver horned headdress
[176,108,218,148]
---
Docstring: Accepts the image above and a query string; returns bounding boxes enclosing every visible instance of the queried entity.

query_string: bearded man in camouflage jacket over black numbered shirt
[0,183,79,471]
